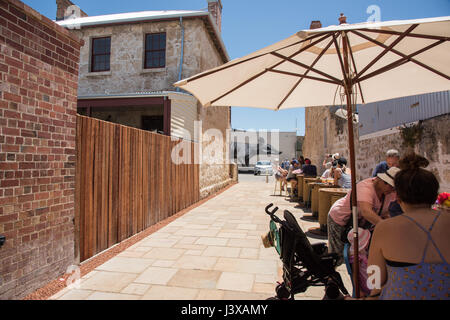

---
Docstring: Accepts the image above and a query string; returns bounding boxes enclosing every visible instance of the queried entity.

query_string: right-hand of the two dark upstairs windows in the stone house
[144,33,166,69]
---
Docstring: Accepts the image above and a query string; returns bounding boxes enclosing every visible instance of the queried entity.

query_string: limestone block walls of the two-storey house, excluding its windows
[72,19,231,197]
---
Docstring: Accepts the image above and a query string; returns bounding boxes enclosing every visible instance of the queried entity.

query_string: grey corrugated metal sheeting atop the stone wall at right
[358,91,450,136]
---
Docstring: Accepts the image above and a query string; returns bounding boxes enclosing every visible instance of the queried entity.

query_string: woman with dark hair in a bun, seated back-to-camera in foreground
[362,154,450,300]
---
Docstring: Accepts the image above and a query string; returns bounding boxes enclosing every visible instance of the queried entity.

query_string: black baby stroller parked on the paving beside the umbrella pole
[265,203,348,300]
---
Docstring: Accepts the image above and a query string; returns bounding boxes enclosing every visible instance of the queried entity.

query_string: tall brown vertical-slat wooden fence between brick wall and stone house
[75,115,199,262]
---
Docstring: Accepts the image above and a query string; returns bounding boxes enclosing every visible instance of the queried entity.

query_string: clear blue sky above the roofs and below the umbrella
[22,0,450,135]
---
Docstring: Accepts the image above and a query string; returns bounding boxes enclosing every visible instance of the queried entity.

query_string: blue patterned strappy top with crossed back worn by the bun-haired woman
[380,212,450,300]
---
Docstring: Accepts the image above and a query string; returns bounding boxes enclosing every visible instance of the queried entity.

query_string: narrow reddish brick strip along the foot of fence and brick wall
[23,183,236,300]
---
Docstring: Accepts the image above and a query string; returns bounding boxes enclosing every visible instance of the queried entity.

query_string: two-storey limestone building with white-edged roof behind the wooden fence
[56,0,231,196]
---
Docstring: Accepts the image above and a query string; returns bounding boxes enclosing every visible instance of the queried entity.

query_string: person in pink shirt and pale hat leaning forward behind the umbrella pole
[327,167,400,264]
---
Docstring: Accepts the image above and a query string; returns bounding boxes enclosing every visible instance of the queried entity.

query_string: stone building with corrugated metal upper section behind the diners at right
[303,91,450,192]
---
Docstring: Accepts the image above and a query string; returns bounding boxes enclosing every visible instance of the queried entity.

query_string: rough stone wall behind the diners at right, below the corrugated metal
[303,107,450,192]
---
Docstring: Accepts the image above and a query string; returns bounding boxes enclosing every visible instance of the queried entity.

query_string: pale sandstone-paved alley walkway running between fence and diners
[50,176,351,300]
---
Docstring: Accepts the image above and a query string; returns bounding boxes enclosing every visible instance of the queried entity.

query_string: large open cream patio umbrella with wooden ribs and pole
[175,14,450,295]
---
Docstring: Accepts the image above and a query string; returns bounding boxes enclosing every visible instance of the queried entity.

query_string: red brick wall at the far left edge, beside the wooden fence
[0,0,82,299]
